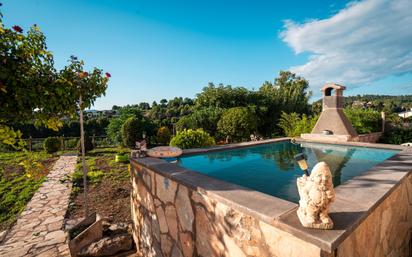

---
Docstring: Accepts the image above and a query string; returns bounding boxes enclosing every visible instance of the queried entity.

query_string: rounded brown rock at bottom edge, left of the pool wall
[78,234,133,256]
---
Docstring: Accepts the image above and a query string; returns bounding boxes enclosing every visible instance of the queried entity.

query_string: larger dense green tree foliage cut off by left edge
[0,8,65,146]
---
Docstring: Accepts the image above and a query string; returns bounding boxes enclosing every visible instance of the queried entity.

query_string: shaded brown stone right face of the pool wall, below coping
[337,174,412,257]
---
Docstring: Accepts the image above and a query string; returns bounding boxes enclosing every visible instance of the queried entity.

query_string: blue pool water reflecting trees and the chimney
[177,141,398,202]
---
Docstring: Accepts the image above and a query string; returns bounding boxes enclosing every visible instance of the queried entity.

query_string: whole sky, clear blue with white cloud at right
[0,0,412,109]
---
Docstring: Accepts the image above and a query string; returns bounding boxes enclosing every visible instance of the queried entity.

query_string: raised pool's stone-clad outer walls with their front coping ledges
[131,148,412,257]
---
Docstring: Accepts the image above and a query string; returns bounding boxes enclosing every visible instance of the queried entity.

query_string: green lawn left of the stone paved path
[0,152,58,231]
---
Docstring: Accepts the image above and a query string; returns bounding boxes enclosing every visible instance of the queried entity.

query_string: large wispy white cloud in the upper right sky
[280,0,412,90]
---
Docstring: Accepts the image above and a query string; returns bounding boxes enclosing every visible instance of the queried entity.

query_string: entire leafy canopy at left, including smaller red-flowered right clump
[0,7,110,145]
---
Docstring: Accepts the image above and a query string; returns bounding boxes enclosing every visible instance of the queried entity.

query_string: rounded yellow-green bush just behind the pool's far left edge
[170,129,215,149]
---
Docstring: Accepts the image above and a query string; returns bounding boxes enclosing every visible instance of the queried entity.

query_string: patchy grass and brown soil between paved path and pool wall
[68,148,131,222]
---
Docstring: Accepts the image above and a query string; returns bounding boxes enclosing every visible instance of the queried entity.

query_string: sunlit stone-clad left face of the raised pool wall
[131,162,322,257]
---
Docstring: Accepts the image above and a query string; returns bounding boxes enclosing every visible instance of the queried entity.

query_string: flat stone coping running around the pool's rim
[131,138,412,253]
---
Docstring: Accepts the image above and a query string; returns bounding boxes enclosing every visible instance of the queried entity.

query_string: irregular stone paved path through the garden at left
[0,156,77,257]
